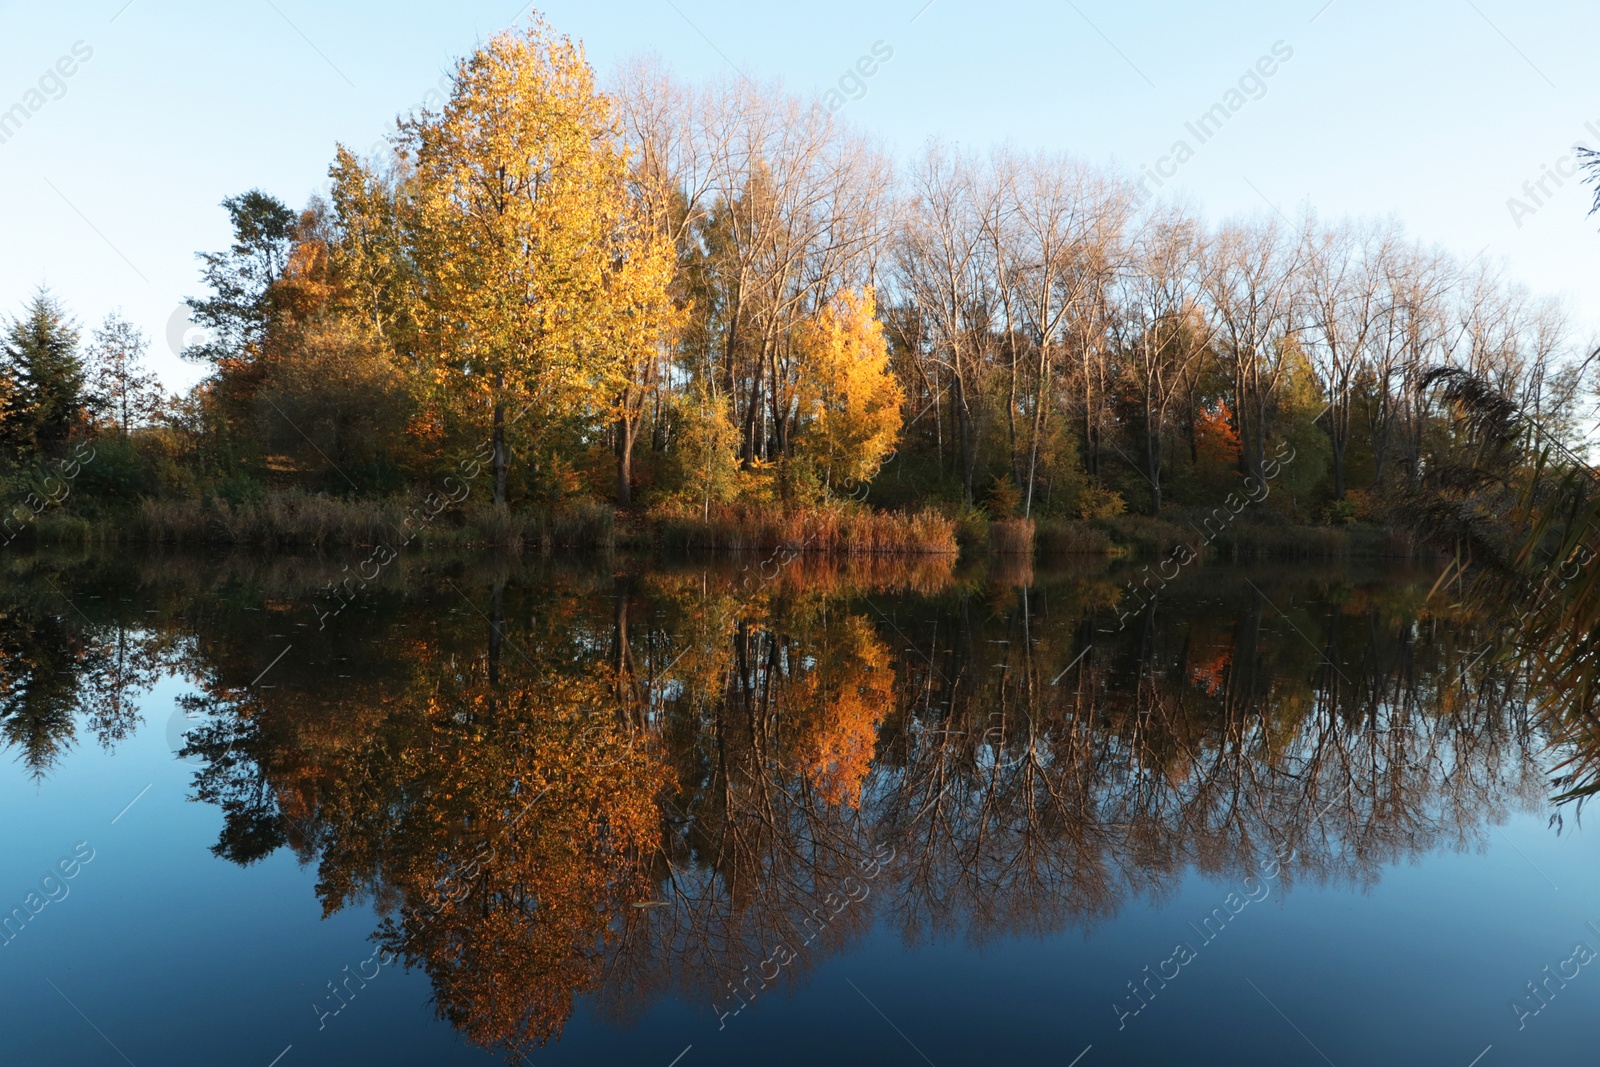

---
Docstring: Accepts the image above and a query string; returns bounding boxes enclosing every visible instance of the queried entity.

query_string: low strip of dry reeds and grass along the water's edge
[0,491,1445,561]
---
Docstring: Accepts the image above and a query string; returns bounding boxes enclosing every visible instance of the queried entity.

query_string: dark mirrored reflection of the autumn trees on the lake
[0,557,1549,1053]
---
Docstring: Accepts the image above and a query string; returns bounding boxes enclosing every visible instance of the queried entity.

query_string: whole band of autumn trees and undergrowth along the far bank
[0,14,1595,563]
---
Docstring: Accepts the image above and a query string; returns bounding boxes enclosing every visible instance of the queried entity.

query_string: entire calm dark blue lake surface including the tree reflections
[0,555,1600,1067]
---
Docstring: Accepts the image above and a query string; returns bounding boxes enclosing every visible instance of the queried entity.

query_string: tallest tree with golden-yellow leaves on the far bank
[400,16,672,504]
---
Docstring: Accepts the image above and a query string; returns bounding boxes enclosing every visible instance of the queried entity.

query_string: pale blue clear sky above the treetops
[0,0,1600,387]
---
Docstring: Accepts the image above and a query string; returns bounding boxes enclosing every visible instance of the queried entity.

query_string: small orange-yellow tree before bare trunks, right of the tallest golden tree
[795,288,904,490]
